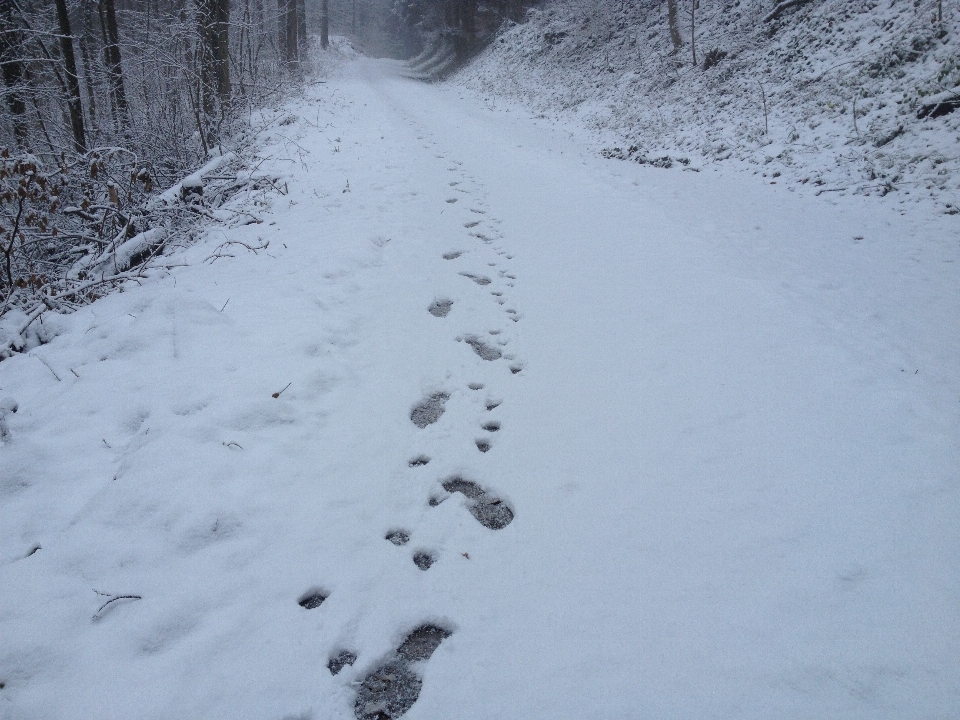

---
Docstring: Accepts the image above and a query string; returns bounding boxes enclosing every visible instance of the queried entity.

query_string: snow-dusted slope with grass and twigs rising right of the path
[458,0,960,214]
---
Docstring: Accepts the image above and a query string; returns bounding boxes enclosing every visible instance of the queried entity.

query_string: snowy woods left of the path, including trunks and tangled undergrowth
[0,0,316,338]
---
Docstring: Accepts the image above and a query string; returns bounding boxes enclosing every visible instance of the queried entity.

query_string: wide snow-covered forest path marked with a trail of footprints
[0,61,960,720]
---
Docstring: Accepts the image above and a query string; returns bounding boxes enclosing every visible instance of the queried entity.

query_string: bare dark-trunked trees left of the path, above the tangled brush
[0,0,318,166]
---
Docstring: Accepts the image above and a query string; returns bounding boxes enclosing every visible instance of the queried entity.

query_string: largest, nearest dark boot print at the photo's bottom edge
[353,625,451,720]
